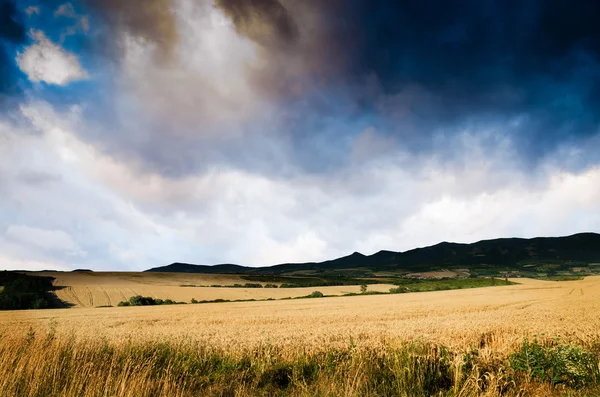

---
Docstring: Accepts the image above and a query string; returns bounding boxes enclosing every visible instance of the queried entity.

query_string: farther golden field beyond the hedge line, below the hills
[30,272,393,308]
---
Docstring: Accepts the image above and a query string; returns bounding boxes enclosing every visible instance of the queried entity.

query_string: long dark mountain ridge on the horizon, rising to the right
[147,233,600,275]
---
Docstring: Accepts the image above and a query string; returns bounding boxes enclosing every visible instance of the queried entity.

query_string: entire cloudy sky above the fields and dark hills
[0,0,600,271]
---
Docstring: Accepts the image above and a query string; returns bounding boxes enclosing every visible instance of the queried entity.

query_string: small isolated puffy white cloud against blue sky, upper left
[16,30,88,86]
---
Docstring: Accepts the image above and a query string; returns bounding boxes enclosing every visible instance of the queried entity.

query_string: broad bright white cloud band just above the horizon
[0,102,600,270]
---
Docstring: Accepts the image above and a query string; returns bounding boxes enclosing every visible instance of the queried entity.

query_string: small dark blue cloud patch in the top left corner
[0,0,27,99]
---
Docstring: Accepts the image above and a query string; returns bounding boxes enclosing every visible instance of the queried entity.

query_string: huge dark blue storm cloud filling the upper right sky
[218,0,600,162]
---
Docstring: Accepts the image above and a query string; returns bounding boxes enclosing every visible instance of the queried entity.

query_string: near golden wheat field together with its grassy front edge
[0,275,600,396]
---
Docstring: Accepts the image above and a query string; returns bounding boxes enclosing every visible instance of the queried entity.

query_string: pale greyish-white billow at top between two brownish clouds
[116,0,265,131]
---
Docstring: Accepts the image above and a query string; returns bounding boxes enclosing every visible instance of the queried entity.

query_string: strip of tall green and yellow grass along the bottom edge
[0,330,600,397]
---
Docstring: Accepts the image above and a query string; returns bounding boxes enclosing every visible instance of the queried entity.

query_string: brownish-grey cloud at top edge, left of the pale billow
[84,0,179,60]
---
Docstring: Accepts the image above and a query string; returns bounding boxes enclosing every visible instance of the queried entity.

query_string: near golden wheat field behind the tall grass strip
[0,277,600,350]
